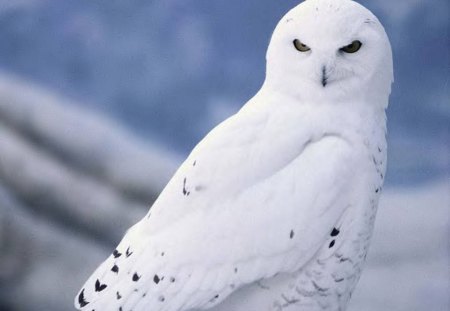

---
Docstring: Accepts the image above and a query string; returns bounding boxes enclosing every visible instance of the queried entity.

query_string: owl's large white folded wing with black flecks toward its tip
[75,104,355,311]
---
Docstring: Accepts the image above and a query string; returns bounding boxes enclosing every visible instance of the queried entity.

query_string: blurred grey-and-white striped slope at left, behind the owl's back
[0,75,179,311]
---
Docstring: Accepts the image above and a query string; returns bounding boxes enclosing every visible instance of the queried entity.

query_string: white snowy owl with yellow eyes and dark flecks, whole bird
[75,0,393,311]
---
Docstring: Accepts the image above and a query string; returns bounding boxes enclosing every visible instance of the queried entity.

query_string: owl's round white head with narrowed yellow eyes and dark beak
[267,0,392,105]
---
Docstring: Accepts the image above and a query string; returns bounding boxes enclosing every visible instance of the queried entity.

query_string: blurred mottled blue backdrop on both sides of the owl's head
[0,0,450,184]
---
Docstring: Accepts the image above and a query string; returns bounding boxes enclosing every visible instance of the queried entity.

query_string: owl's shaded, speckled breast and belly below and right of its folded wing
[210,121,386,311]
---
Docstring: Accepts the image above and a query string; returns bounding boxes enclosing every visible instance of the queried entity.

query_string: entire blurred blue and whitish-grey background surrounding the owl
[0,0,450,311]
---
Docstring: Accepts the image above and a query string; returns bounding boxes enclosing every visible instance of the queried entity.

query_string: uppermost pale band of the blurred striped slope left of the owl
[0,75,179,204]
